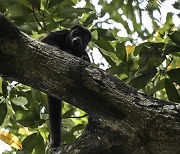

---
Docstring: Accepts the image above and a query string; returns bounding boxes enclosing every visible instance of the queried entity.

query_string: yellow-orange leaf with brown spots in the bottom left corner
[0,131,23,150]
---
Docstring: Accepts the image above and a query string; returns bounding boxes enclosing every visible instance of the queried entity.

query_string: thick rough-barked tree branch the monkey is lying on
[0,14,180,154]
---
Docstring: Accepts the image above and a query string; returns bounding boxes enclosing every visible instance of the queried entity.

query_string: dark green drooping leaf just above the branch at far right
[165,79,180,102]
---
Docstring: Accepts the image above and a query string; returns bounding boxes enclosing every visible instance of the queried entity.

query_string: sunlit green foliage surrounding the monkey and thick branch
[0,0,180,153]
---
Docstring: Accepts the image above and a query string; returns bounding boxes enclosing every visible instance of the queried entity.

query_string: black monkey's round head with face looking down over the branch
[66,25,91,51]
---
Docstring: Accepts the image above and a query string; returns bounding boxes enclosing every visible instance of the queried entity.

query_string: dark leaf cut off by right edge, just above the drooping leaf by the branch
[167,68,180,85]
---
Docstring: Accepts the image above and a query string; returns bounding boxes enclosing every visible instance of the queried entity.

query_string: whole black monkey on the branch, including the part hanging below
[42,25,91,148]
